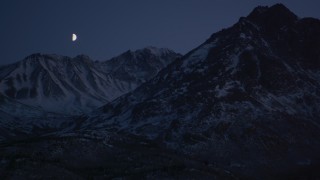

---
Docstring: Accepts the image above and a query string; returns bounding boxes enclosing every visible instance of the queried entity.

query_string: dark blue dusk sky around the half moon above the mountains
[0,0,320,65]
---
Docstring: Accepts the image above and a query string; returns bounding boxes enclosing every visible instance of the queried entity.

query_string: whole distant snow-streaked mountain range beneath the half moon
[0,47,180,115]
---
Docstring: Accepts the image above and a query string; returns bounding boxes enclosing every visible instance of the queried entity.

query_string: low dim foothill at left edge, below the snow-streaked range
[0,93,72,143]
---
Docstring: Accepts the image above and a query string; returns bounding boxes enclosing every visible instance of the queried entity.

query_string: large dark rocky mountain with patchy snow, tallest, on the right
[79,4,320,179]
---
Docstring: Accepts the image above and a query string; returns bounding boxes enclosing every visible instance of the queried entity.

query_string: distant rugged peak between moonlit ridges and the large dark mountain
[102,46,180,84]
